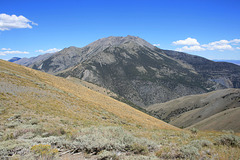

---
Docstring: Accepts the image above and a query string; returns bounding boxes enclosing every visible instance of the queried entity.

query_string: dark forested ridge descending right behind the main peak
[164,50,240,88]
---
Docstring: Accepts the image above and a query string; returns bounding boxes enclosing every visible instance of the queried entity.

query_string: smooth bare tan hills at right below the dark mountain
[147,88,240,132]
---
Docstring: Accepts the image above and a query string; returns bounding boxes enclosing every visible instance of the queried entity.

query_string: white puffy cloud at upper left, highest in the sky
[0,13,38,31]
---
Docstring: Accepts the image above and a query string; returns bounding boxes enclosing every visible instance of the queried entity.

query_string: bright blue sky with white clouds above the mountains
[0,0,240,60]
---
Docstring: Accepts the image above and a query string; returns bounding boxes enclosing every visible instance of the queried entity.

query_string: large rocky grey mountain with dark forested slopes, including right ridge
[13,36,240,107]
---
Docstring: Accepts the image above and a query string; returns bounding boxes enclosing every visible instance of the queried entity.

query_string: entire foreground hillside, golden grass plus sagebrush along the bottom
[0,60,240,160]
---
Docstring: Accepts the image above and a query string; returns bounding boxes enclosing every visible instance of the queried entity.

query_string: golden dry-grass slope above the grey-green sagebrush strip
[0,60,175,129]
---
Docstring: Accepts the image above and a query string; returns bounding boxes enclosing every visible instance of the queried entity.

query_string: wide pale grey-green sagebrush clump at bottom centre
[31,127,156,154]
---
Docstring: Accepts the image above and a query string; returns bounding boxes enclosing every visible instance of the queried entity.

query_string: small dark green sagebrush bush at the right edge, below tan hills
[216,134,240,147]
